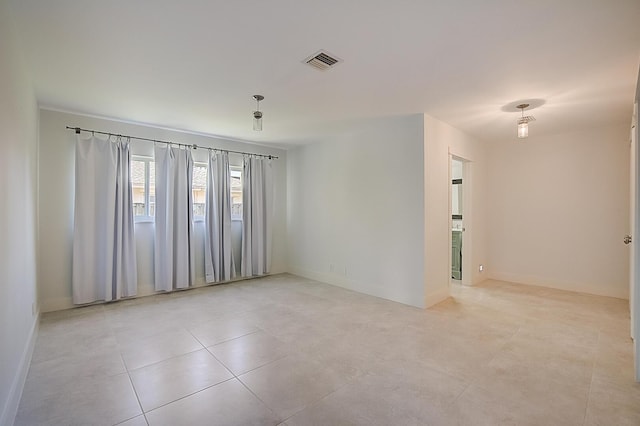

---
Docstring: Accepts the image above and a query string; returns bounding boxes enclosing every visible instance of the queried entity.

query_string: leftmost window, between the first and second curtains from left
[131,157,156,221]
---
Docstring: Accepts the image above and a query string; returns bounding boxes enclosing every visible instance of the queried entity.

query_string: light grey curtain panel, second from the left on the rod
[154,144,195,291]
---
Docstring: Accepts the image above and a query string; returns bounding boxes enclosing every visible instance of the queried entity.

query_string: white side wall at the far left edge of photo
[0,1,38,426]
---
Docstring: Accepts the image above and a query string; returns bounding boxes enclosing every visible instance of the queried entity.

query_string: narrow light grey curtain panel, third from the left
[205,152,236,283]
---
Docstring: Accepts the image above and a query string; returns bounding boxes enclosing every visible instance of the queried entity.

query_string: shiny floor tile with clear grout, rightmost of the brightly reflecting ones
[208,331,288,375]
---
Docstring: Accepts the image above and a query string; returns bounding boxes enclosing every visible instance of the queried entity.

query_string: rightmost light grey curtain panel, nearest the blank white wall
[241,156,273,277]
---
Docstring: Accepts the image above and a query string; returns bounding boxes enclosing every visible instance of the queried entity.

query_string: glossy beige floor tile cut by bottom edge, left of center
[146,379,281,426]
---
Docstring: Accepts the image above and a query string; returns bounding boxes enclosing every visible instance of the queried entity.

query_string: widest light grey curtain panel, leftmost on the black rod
[71,136,138,304]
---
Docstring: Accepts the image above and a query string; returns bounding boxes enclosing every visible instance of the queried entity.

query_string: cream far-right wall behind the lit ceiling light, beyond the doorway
[487,124,629,298]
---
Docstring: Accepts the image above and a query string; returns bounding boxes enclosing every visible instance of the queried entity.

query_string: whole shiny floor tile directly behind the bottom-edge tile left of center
[129,349,233,412]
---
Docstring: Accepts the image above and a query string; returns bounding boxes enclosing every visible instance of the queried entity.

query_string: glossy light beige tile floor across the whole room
[15,275,640,426]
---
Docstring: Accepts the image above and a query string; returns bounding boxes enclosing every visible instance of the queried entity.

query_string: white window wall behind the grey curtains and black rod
[38,109,287,311]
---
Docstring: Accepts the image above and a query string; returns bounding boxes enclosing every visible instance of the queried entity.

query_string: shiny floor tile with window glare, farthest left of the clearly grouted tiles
[121,329,203,370]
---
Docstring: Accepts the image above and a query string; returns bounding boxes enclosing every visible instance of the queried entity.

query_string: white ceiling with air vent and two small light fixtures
[9,0,640,146]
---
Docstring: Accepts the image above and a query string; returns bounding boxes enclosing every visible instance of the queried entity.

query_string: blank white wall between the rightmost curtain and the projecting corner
[287,115,428,307]
